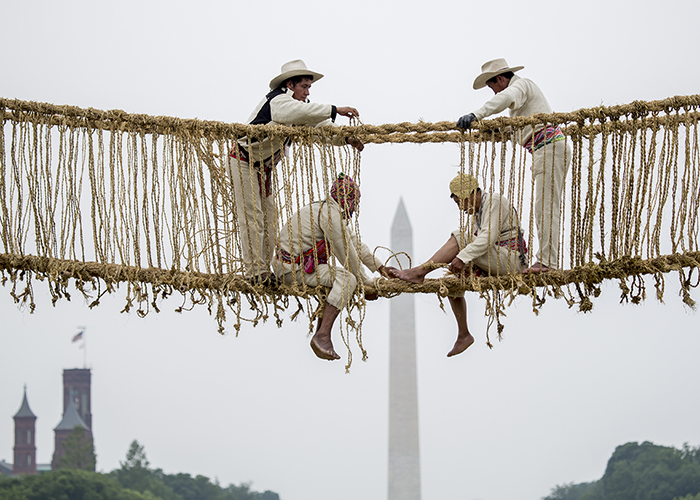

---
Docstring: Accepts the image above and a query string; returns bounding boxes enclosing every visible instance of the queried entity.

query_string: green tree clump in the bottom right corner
[542,441,700,500]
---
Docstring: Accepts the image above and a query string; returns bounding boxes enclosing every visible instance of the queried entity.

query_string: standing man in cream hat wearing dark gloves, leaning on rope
[457,59,572,273]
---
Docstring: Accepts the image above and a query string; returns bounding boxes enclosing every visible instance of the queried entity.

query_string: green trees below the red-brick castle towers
[0,432,279,500]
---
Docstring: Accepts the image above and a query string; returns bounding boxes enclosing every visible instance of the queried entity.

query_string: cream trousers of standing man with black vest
[228,157,277,277]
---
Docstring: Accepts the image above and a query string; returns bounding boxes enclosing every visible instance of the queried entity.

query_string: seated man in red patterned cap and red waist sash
[272,174,384,361]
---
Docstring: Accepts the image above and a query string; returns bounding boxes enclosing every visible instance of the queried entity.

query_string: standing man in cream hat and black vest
[228,59,364,285]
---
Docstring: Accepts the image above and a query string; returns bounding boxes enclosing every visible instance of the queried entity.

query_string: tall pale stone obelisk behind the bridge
[388,199,421,500]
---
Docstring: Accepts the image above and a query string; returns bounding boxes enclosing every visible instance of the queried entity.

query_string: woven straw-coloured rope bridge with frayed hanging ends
[0,95,700,355]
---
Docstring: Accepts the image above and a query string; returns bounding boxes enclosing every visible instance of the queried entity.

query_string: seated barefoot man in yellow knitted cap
[386,174,527,357]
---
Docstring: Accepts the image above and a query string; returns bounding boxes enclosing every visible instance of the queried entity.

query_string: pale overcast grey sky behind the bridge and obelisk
[0,0,700,500]
